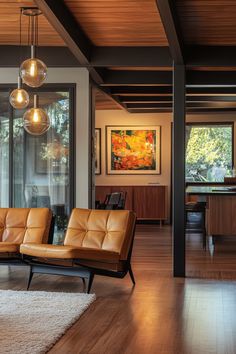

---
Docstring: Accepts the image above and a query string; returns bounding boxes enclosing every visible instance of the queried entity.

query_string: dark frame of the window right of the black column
[185,121,234,186]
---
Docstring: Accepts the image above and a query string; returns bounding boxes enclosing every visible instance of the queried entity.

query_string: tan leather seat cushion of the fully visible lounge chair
[20,243,119,263]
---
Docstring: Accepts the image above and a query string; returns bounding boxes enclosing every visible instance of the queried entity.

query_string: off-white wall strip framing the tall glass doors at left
[0,68,90,208]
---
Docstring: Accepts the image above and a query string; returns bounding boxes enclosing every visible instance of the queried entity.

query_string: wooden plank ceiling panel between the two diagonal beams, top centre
[65,0,168,46]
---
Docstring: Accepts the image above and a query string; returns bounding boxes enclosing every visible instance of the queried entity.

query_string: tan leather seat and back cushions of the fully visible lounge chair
[20,209,135,269]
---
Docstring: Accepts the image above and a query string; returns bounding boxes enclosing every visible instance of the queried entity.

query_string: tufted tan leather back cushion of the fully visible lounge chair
[64,208,135,259]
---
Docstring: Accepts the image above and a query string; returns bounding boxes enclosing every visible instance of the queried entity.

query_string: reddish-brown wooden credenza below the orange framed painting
[96,185,168,220]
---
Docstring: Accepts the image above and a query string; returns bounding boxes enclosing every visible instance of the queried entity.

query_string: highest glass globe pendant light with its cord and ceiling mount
[20,7,47,87]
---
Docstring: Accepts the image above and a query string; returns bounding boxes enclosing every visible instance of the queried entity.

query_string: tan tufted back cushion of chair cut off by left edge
[0,208,52,244]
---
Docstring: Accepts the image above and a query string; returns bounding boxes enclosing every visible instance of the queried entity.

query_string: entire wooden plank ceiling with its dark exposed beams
[0,0,236,113]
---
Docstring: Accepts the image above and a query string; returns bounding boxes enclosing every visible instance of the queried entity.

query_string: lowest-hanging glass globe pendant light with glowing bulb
[23,95,50,135]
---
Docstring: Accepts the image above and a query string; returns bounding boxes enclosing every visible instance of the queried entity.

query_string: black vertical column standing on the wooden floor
[172,64,185,277]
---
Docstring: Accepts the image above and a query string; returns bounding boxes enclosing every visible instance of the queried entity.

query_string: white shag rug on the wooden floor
[0,290,95,354]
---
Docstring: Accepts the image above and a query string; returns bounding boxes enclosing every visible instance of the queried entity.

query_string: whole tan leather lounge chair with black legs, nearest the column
[20,209,136,293]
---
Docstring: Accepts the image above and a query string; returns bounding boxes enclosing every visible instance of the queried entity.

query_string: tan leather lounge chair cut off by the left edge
[0,208,52,264]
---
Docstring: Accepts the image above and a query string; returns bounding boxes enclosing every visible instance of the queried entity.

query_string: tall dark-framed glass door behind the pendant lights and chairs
[0,85,74,242]
